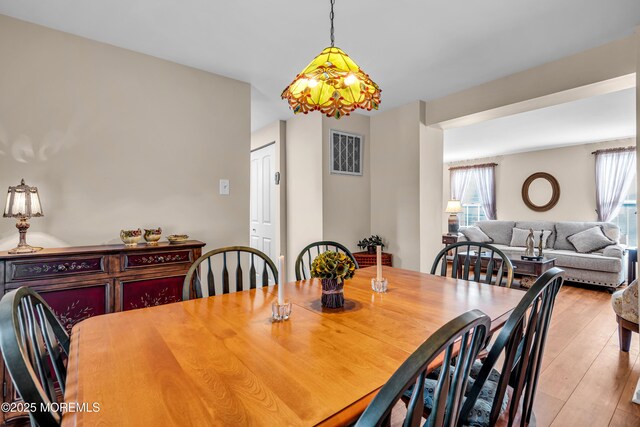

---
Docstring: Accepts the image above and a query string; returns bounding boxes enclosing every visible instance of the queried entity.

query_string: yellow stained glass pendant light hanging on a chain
[282,0,380,119]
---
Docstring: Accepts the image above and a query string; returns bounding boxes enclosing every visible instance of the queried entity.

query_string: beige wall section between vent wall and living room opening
[371,102,424,270]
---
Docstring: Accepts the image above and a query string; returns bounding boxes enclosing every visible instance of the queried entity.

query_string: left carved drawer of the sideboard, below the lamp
[6,255,108,282]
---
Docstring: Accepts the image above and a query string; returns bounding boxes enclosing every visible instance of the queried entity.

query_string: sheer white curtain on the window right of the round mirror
[595,148,636,222]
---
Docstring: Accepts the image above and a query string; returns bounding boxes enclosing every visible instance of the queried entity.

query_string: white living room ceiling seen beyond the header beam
[444,88,636,162]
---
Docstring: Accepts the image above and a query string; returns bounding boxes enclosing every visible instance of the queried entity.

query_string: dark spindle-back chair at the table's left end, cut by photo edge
[0,287,69,426]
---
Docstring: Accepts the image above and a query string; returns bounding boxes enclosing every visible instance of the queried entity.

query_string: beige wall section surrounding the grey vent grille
[322,113,376,251]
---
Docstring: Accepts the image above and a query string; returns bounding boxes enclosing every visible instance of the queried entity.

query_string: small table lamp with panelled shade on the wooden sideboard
[3,179,42,254]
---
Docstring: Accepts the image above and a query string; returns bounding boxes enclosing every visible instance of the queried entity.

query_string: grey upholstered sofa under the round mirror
[459,221,626,288]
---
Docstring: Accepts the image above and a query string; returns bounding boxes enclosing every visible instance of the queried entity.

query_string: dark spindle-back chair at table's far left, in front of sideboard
[182,246,278,301]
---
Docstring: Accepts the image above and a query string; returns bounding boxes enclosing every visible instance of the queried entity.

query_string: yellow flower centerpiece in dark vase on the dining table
[311,251,356,308]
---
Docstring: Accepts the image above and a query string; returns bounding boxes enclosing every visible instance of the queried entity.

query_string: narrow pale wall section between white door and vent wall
[286,114,323,279]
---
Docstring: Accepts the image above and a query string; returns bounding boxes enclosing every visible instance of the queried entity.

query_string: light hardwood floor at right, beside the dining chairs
[393,285,640,427]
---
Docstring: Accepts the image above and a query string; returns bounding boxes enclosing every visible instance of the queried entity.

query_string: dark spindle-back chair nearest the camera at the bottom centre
[356,310,491,427]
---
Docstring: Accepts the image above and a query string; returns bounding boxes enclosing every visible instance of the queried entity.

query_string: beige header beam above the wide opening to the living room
[426,36,637,128]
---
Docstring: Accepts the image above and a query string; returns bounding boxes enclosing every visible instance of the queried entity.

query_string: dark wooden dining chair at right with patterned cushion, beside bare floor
[408,267,564,427]
